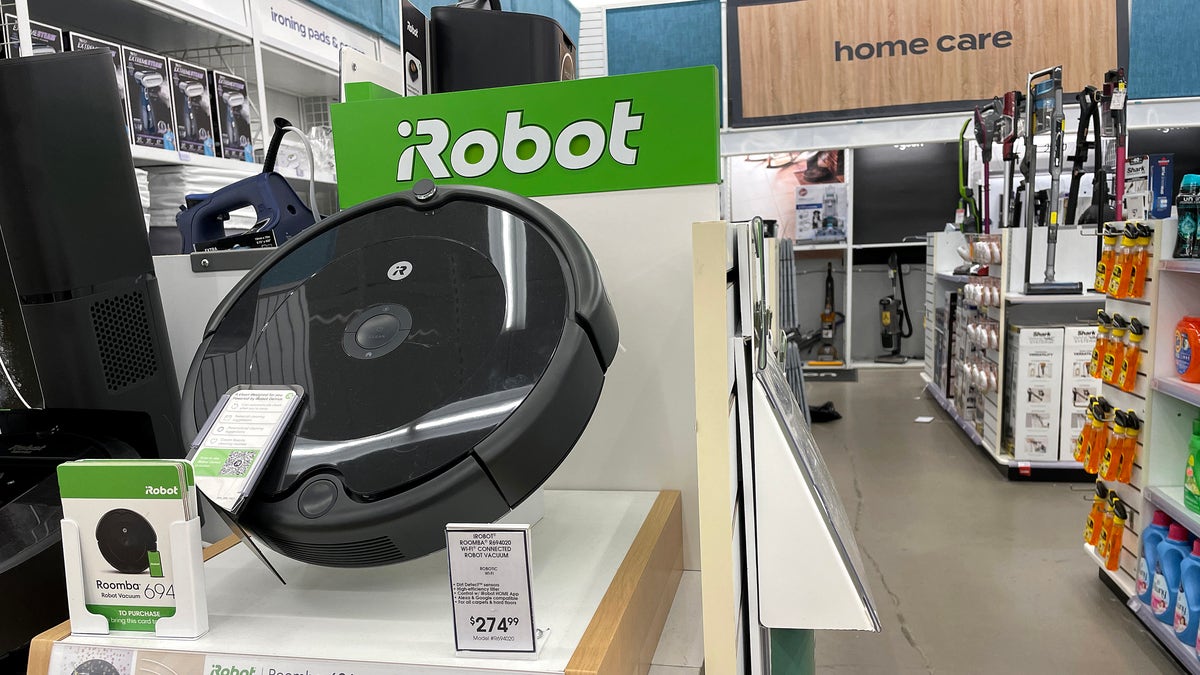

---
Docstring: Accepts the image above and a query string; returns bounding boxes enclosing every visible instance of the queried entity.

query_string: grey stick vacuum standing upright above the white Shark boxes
[1022,66,1084,295]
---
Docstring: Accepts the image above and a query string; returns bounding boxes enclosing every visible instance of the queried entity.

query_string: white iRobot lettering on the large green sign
[396,101,643,183]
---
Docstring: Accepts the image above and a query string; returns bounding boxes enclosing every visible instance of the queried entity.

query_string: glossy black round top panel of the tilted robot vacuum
[192,201,572,501]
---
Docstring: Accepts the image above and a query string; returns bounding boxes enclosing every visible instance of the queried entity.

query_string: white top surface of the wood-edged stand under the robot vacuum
[55,491,658,675]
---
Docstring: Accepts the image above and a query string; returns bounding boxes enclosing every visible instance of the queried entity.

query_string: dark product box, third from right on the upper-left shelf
[121,47,176,150]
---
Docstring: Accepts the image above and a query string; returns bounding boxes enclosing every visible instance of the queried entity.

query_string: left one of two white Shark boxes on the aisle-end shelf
[1006,325,1063,461]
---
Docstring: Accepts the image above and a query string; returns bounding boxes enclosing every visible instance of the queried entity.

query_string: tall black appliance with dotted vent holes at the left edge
[0,49,185,458]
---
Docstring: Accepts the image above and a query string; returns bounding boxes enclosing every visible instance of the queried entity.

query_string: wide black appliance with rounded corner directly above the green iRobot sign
[430,0,575,94]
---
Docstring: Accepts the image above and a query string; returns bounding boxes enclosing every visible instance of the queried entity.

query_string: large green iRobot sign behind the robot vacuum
[331,66,720,208]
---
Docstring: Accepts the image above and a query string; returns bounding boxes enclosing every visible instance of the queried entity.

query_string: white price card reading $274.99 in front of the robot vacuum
[446,524,536,653]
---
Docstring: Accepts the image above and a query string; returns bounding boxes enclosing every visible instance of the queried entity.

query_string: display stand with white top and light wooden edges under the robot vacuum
[28,490,683,675]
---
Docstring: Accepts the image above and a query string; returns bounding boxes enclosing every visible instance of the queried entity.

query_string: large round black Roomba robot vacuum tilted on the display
[182,180,618,567]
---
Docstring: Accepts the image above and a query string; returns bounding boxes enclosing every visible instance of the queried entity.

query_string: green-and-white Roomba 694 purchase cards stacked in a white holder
[58,460,199,633]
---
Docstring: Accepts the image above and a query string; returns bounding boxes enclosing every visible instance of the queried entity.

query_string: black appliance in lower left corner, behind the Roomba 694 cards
[0,410,155,657]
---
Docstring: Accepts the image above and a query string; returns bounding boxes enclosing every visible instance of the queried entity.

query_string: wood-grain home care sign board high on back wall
[728,0,1117,126]
